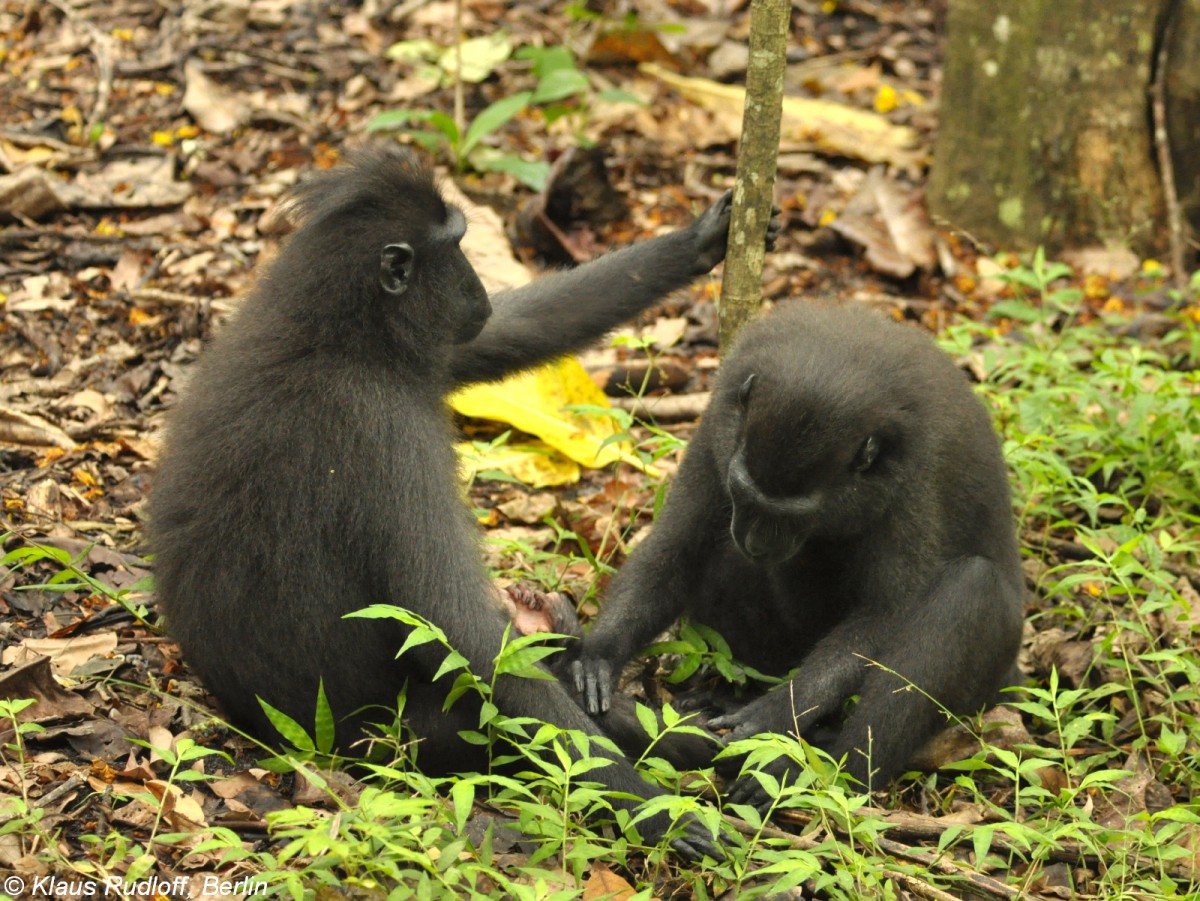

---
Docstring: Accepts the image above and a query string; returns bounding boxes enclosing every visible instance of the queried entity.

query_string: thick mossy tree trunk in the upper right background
[928,0,1200,263]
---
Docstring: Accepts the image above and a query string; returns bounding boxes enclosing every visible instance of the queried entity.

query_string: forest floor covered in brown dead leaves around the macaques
[0,0,1200,897]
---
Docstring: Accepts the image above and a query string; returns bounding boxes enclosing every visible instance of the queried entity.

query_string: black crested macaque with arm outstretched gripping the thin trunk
[149,144,778,857]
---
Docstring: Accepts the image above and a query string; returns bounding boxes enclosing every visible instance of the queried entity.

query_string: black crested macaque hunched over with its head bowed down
[571,302,1024,807]
